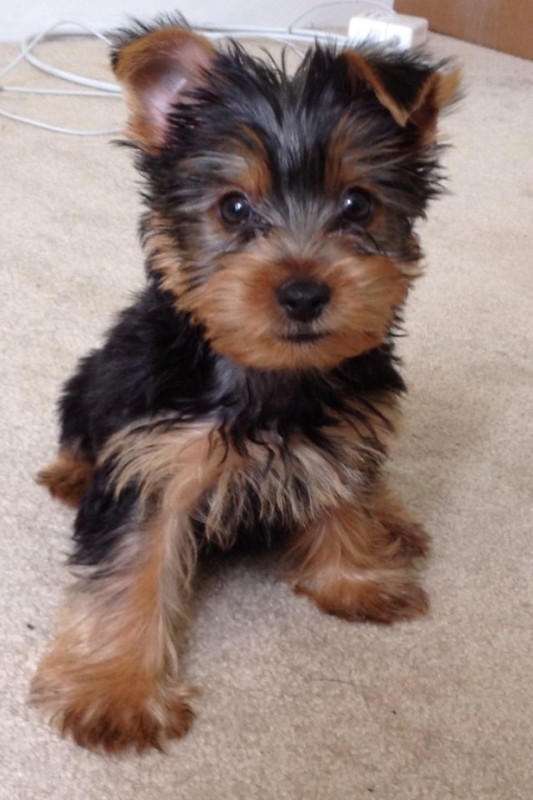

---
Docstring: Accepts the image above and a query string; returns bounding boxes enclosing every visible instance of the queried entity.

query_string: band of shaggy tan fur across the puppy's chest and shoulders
[101,396,398,544]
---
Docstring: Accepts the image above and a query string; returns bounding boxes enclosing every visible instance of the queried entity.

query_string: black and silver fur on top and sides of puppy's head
[137,44,442,268]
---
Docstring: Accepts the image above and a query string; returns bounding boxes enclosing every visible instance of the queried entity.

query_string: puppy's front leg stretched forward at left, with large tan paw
[31,422,222,753]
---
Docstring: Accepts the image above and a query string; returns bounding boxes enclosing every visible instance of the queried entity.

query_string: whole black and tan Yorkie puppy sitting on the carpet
[32,18,458,752]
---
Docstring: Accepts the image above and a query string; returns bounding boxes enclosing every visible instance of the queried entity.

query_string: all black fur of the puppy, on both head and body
[52,25,448,564]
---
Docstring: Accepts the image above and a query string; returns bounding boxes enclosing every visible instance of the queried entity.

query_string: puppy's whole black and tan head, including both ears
[114,21,457,369]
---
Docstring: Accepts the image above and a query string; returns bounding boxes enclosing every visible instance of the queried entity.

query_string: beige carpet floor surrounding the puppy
[0,31,533,800]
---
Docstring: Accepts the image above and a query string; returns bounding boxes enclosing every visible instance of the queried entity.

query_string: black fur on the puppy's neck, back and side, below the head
[64,281,405,564]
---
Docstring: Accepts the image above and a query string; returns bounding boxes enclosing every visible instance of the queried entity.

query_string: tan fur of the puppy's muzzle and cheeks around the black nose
[160,230,415,369]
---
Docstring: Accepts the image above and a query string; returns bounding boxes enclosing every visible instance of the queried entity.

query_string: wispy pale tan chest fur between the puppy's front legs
[194,435,376,546]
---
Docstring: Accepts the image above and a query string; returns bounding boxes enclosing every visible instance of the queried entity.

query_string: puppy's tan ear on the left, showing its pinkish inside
[111,26,215,154]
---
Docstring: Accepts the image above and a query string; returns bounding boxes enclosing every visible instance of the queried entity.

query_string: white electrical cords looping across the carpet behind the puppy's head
[0,0,394,136]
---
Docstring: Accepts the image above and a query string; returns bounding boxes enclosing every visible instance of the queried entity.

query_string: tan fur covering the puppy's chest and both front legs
[32,395,425,753]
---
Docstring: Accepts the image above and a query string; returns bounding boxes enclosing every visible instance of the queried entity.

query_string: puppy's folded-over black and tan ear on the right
[340,50,461,141]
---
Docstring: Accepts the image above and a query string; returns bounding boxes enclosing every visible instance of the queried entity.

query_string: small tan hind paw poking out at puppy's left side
[37,447,95,507]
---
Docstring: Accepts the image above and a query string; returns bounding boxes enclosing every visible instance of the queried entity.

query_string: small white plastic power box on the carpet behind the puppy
[348,9,428,50]
